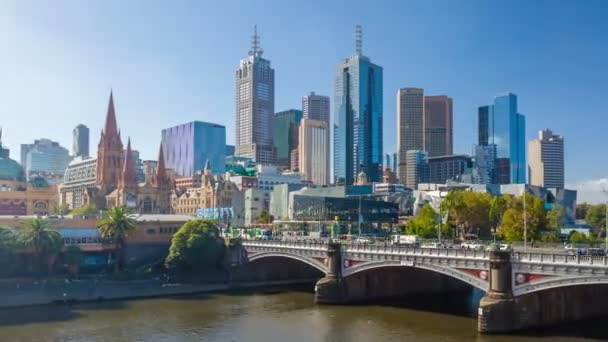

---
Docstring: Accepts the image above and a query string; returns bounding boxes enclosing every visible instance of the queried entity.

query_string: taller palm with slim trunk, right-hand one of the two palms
[97,207,135,272]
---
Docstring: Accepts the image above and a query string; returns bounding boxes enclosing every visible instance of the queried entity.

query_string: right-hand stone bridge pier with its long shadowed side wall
[478,251,608,333]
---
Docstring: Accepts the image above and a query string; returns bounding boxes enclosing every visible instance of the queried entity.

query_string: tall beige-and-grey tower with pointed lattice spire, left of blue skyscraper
[235,26,275,165]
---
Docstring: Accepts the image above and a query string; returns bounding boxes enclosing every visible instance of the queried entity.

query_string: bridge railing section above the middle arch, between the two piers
[346,245,489,259]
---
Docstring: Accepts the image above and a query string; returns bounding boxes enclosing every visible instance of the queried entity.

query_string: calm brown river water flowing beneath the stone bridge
[0,288,608,342]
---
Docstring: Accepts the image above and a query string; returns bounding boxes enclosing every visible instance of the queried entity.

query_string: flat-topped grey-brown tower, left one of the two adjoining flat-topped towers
[397,88,424,184]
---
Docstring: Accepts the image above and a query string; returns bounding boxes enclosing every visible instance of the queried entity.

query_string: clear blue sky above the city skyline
[0,0,608,195]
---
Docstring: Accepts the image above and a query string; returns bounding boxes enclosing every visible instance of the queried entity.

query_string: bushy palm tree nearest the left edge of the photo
[20,218,63,272]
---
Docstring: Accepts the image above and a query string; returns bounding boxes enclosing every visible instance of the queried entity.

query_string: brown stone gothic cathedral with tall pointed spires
[60,93,173,214]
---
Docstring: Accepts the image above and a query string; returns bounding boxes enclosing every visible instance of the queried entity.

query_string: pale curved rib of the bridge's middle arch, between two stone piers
[342,261,489,292]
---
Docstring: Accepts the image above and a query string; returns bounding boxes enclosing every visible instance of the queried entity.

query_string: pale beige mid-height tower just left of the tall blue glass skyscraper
[298,119,329,185]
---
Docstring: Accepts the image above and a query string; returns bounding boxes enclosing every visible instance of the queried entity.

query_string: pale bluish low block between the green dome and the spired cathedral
[21,139,72,184]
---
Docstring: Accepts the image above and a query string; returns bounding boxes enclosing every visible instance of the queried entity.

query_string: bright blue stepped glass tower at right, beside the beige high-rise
[478,93,526,184]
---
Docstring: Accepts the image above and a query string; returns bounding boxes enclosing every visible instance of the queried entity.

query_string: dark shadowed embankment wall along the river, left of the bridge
[0,279,316,309]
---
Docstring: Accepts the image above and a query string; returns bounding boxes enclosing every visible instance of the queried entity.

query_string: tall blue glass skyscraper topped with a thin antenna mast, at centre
[334,25,383,185]
